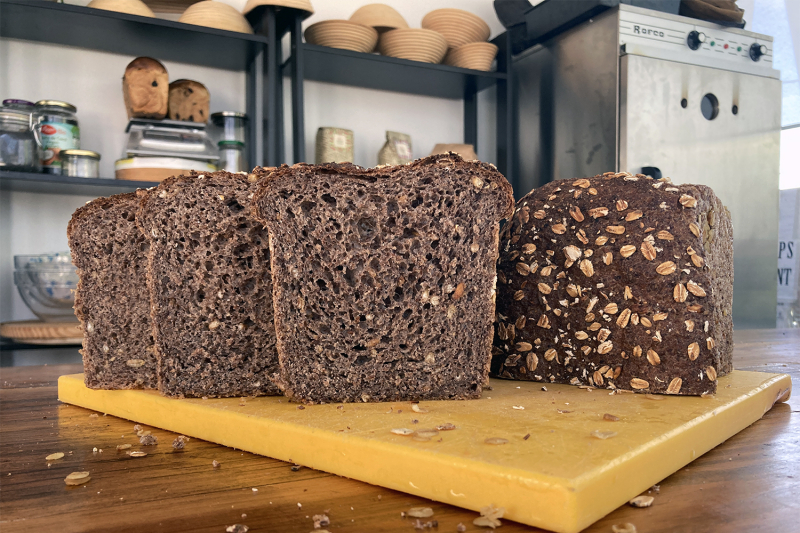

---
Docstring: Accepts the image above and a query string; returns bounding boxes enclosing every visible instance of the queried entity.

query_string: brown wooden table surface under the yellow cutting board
[0,330,800,533]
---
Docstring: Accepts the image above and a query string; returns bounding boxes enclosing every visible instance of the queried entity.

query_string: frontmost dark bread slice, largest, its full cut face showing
[254,154,513,403]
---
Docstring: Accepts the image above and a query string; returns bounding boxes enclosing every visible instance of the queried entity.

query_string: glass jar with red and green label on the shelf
[31,100,81,174]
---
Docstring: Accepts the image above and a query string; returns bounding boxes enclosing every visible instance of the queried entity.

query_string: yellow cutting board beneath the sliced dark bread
[58,371,791,533]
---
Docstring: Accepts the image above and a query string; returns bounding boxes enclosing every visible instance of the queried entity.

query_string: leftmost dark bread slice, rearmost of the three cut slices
[67,193,157,389]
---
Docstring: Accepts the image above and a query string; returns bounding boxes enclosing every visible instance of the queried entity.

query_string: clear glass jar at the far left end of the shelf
[0,107,41,172]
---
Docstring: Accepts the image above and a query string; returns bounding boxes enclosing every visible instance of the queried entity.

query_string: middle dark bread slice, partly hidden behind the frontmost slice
[138,172,278,397]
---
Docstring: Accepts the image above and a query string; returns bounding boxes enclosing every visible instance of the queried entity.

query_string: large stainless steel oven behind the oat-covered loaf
[512,4,781,328]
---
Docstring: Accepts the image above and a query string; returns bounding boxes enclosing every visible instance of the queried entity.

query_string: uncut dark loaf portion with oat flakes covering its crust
[492,173,733,395]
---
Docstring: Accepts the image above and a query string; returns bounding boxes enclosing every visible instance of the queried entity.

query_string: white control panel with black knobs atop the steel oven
[619,6,773,71]
